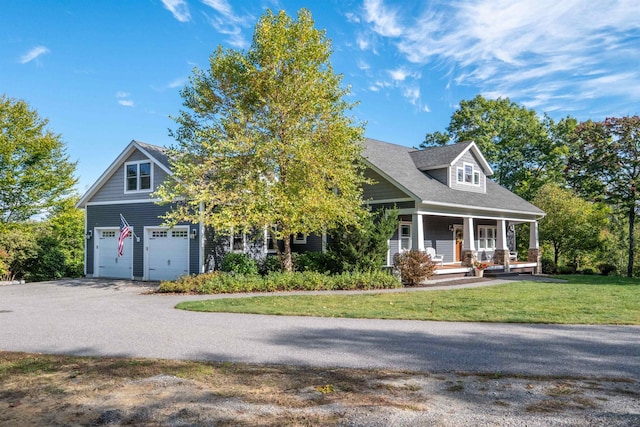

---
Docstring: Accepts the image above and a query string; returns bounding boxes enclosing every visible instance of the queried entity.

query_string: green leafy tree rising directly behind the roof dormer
[421,95,576,200]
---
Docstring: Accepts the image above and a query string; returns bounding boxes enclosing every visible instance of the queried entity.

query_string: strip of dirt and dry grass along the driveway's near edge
[0,352,640,426]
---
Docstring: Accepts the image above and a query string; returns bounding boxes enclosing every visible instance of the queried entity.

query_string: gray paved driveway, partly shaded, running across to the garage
[0,280,640,379]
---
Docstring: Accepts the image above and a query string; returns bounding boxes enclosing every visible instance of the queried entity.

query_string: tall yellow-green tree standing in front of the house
[157,9,365,271]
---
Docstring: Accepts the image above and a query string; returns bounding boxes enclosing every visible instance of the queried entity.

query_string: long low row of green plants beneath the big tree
[159,271,401,294]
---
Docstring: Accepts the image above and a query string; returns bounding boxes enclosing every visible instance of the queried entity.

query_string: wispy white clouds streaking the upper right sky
[357,0,640,118]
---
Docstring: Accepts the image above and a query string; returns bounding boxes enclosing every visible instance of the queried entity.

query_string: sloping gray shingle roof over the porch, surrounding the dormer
[363,139,544,217]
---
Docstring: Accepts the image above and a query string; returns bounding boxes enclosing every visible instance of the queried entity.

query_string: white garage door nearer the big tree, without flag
[145,227,189,280]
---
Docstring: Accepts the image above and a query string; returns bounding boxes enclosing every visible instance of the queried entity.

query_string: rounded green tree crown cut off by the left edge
[0,95,76,223]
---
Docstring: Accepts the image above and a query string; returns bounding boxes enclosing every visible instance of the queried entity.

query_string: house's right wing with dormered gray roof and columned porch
[363,139,544,274]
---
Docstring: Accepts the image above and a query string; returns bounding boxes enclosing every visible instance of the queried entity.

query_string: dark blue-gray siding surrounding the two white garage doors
[86,203,200,278]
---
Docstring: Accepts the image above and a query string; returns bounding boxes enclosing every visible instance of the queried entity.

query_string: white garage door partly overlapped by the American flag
[93,227,133,279]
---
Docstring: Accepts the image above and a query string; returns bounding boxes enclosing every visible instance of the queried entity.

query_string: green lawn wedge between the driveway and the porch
[177,276,640,325]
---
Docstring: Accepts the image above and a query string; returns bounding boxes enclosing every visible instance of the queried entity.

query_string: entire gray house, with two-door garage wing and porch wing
[77,139,544,280]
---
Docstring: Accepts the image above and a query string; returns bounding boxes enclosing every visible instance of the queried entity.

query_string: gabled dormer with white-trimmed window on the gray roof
[410,142,493,193]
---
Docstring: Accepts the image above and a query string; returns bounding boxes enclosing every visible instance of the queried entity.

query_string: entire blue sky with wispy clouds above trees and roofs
[5,0,640,193]
